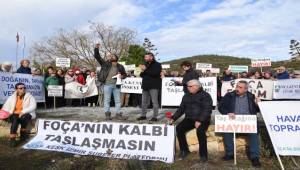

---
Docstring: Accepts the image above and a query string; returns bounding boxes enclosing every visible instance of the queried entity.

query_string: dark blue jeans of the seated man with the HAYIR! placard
[223,133,259,159]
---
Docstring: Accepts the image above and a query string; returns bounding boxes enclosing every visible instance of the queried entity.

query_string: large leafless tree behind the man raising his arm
[30,23,136,68]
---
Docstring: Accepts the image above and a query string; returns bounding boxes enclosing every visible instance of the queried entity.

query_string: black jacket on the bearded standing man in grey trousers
[140,60,161,90]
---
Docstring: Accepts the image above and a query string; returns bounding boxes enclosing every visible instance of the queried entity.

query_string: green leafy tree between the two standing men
[121,45,146,66]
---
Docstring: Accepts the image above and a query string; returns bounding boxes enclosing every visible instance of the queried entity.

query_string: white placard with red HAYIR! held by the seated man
[215,115,257,133]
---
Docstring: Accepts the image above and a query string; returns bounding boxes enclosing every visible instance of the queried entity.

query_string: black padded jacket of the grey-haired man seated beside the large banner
[172,89,213,122]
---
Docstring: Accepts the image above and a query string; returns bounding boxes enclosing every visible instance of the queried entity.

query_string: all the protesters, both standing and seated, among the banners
[0,54,300,167]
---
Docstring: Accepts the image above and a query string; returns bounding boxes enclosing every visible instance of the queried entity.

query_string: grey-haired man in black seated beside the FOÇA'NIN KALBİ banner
[171,80,212,162]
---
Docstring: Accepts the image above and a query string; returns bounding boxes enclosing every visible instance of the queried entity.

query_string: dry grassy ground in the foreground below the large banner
[0,107,300,170]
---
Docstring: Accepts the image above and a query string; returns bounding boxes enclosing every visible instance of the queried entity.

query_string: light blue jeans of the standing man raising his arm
[103,84,121,113]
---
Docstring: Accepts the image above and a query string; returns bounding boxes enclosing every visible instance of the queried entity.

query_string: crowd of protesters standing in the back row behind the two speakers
[0,59,300,108]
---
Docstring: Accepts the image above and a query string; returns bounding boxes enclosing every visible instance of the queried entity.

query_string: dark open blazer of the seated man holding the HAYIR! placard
[218,91,259,115]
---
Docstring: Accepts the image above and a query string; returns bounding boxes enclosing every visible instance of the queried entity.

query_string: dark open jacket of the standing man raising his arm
[94,48,126,83]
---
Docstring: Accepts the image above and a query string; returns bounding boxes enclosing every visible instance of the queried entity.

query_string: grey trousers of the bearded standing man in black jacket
[142,89,159,118]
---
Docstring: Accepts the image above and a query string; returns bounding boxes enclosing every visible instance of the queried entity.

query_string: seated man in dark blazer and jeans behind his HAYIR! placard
[219,81,261,167]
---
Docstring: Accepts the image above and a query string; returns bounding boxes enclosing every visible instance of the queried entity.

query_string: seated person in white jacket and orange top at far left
[2,83,36,147]
